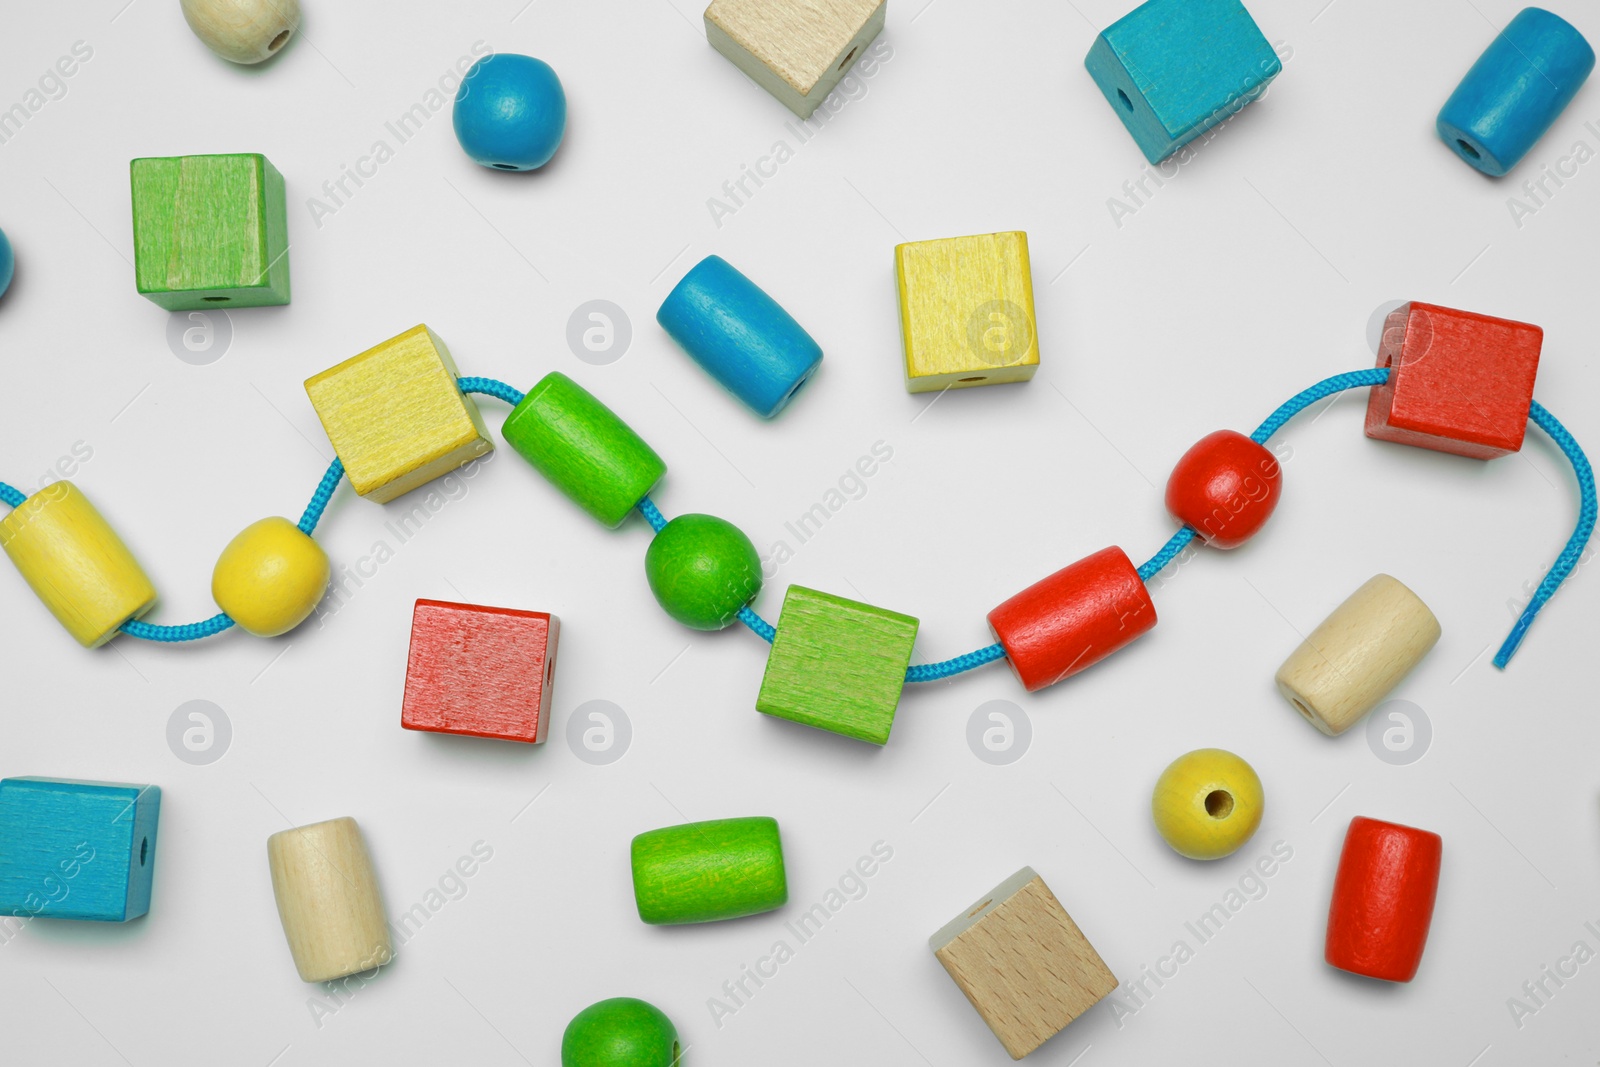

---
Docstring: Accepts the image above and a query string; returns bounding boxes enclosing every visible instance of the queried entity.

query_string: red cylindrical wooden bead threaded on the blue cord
[989,549,1155,693]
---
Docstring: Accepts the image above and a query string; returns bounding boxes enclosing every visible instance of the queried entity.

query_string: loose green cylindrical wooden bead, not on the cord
[632,816,789,926]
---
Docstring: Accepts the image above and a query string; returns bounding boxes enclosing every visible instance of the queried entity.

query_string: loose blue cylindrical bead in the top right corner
[1438,8,1595,178]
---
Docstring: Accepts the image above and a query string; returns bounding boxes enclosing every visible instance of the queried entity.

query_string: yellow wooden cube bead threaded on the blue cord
[306,326,494,504]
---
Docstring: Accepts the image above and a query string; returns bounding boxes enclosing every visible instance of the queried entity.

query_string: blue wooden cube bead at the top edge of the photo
[1083,0,1283,163]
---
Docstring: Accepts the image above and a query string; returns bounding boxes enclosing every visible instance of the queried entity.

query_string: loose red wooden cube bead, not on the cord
[400,600,562,744]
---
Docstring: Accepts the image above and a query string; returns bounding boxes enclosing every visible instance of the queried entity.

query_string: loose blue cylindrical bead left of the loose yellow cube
[656,256,822,419]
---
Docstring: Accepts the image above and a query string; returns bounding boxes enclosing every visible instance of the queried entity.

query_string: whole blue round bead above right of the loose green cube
[454,53,566,171]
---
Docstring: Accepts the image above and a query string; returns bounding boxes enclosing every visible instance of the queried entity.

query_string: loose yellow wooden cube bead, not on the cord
[894,232,1038,392]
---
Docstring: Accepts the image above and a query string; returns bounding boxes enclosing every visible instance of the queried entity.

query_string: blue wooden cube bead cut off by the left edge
[0,777,162,923]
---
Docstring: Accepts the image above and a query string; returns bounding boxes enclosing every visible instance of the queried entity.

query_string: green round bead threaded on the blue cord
[645,515,762,630]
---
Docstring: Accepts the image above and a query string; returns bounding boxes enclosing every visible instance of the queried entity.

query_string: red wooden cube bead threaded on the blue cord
[1366,301,1544,459]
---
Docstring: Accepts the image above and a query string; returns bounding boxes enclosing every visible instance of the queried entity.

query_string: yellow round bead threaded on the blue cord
[211,517,330,637]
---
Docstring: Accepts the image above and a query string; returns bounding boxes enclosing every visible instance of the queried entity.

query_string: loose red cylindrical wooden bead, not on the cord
[1323,817,1443,982]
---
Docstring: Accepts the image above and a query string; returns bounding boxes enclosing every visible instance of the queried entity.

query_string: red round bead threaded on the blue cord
[1166,430,1283,549]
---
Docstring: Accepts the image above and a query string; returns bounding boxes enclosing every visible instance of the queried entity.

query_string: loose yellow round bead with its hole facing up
[1150,749,1264,859]
